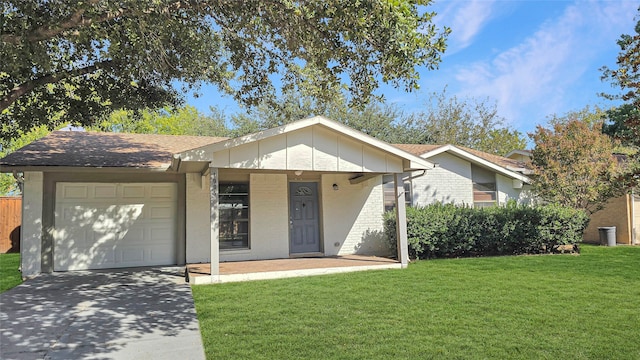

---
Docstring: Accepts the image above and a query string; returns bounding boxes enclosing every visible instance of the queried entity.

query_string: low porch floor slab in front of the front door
[186,255,402,285]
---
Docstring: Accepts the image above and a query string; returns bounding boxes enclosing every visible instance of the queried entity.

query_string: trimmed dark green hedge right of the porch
[384,202,589,259]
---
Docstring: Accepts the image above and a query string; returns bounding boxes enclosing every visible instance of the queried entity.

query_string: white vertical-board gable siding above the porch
[212,126,403,173]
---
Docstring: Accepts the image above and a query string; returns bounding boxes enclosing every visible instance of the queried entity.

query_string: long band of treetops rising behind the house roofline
[93,90,526,155]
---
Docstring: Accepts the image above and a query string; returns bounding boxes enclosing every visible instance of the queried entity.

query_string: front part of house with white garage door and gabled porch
[0,117,434,282]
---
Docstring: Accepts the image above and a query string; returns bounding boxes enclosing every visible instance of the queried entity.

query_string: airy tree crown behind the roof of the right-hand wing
[408,89,526,156]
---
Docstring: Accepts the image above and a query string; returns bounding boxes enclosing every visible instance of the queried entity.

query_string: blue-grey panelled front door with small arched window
[289,182,320,254]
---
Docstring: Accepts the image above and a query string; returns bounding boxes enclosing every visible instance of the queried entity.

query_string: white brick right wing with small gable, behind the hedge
[386,144,532,207]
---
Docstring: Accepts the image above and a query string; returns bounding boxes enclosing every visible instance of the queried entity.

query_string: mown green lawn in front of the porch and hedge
[193,246,640,359]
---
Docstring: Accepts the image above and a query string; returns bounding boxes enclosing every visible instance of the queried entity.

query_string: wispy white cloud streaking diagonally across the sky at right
[455,1,637,129]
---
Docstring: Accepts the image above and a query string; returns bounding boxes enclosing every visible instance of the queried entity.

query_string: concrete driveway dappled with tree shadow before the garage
[0,267,205,359]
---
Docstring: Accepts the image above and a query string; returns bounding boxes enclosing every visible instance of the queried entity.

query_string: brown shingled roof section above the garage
[0,131,227,169]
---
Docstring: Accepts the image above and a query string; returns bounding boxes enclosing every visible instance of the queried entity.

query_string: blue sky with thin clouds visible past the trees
[188,0,640,138]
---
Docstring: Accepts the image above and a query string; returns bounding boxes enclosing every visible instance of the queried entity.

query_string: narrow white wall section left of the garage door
[20,172,44,278]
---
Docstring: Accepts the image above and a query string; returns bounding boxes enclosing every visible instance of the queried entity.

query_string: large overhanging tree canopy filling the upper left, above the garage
[0,0,449,139]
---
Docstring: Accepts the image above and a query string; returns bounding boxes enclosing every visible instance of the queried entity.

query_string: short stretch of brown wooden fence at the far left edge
[0,197,22,254]
